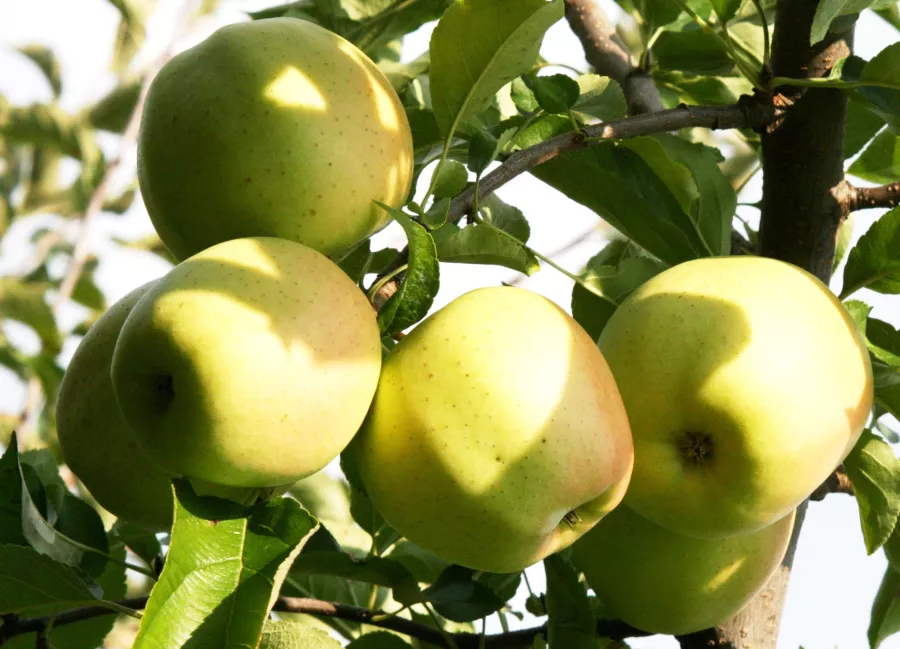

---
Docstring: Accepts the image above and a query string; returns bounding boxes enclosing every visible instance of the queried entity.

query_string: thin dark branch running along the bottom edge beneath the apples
[0,597,650,649]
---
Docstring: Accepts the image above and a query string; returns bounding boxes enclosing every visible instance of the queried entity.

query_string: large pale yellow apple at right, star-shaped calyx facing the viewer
[599,257,874,538]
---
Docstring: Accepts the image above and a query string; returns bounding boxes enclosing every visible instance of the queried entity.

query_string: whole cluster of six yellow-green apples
[57,13,873,634]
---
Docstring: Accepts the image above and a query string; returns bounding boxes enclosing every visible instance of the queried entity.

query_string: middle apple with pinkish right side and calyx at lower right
[351,287,633,573]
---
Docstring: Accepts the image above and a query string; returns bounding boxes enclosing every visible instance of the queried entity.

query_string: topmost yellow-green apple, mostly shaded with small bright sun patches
[138,18,413,260]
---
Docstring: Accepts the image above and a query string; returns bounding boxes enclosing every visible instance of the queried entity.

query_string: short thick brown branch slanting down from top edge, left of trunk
[566,0,665,115]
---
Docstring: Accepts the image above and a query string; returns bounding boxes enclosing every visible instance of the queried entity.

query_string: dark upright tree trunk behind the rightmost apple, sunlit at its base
[679,0,852,649]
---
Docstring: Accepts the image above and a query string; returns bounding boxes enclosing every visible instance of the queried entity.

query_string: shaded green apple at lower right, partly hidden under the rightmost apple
[572,505,794,635]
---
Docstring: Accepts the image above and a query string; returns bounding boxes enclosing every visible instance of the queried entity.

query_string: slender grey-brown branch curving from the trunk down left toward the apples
[375,95,781,307]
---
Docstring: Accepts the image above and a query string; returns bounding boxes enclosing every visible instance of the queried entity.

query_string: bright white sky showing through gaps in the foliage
[0,0,900,649]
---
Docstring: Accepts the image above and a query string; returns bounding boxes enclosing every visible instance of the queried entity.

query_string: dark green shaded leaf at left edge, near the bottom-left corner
[0,545,108,615]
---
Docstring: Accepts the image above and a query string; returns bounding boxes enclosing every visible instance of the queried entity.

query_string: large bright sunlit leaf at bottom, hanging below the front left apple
[134,480,317,649]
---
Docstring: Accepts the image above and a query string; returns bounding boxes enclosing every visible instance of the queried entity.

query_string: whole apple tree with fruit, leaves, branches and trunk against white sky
[0,0,900,649]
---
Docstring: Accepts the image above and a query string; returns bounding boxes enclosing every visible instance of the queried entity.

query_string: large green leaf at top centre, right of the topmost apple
[430,0,563,137]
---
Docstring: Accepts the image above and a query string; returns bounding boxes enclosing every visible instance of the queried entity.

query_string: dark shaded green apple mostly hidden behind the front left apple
[56,282,173,530]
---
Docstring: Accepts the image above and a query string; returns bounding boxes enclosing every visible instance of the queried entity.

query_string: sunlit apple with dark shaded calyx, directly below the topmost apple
[112,237,381,492]
